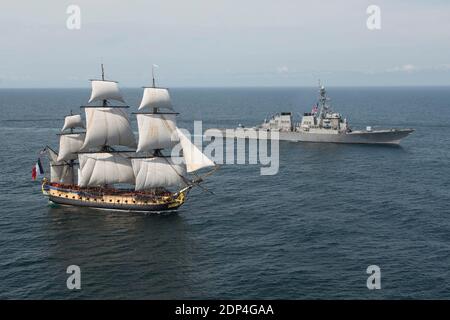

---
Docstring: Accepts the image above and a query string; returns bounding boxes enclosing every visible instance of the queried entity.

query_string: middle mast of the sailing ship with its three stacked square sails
[78,64,136,187]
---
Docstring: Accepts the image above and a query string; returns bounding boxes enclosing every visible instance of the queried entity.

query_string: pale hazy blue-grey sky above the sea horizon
[0,0,450,88]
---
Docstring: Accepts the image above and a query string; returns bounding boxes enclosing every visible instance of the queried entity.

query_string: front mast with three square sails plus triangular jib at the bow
[131,65,215,190]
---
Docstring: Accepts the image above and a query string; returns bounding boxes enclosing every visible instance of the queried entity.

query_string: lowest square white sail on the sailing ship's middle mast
[78,152,134,187]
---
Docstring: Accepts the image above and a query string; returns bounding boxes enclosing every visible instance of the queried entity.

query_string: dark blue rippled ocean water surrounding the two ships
[0,87,450,299]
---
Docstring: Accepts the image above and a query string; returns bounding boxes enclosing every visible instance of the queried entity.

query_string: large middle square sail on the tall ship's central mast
[82,108,136,150]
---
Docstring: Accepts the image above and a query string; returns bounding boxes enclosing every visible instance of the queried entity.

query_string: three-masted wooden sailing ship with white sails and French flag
[42,65,218,212]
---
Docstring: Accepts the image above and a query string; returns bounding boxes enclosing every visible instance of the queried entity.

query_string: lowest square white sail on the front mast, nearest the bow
[131,158,186,190]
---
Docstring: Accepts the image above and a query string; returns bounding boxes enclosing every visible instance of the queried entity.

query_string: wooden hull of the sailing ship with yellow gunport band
[42,181,188,212]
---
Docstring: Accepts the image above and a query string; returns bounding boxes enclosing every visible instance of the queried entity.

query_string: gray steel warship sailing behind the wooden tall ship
[212,85,414,144]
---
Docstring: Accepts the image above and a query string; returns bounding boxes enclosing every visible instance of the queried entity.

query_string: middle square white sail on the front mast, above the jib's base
[136,113,179,152]
